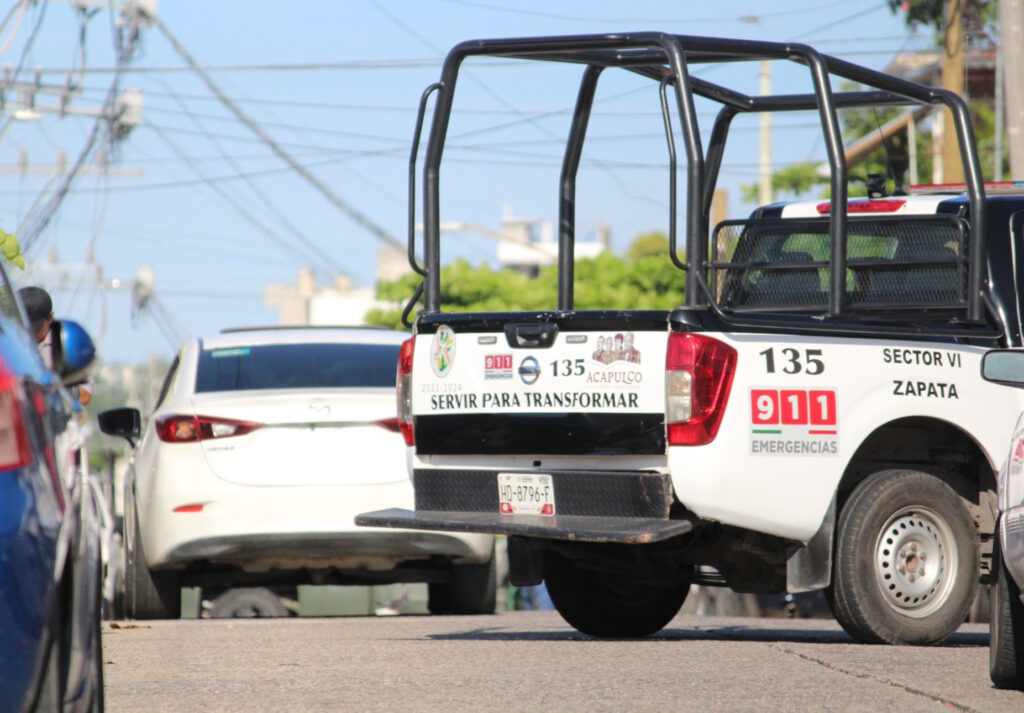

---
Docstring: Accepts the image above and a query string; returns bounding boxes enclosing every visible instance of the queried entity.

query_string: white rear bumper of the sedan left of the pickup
[138,477,493,572]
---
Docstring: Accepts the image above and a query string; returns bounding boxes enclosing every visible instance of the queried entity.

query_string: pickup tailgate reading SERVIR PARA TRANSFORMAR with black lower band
[411,312,668,455]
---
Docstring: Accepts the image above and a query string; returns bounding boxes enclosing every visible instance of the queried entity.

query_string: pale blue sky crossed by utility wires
[0,0,931,362]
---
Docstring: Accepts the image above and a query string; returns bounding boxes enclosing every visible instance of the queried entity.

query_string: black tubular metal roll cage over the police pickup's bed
[404,32,986,323]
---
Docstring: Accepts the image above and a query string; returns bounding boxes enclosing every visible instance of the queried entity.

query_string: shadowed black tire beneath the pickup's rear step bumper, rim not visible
[544,551,689,638]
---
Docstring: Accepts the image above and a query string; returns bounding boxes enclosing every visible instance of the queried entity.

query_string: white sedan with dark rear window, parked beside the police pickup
[99,327,496,619]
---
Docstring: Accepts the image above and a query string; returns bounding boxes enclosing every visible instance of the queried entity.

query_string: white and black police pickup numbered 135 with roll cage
[357,33,1024,643]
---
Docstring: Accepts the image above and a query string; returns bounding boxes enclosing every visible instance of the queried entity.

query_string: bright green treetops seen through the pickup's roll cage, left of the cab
[367,233,686,329]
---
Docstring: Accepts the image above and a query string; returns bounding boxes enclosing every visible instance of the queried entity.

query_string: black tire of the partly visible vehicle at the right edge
[988,537,1024,689]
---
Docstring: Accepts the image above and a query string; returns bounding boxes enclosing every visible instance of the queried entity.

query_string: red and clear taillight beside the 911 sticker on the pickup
[665,332,736,446]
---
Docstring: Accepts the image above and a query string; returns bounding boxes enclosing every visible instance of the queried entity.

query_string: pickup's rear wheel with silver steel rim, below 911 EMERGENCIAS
[826,470,978,644]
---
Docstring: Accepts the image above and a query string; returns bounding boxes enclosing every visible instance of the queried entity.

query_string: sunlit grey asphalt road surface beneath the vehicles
[103,612,1024,713]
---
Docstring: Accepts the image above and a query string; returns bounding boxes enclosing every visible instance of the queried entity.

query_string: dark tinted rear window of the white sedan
[196,343,399,392]
